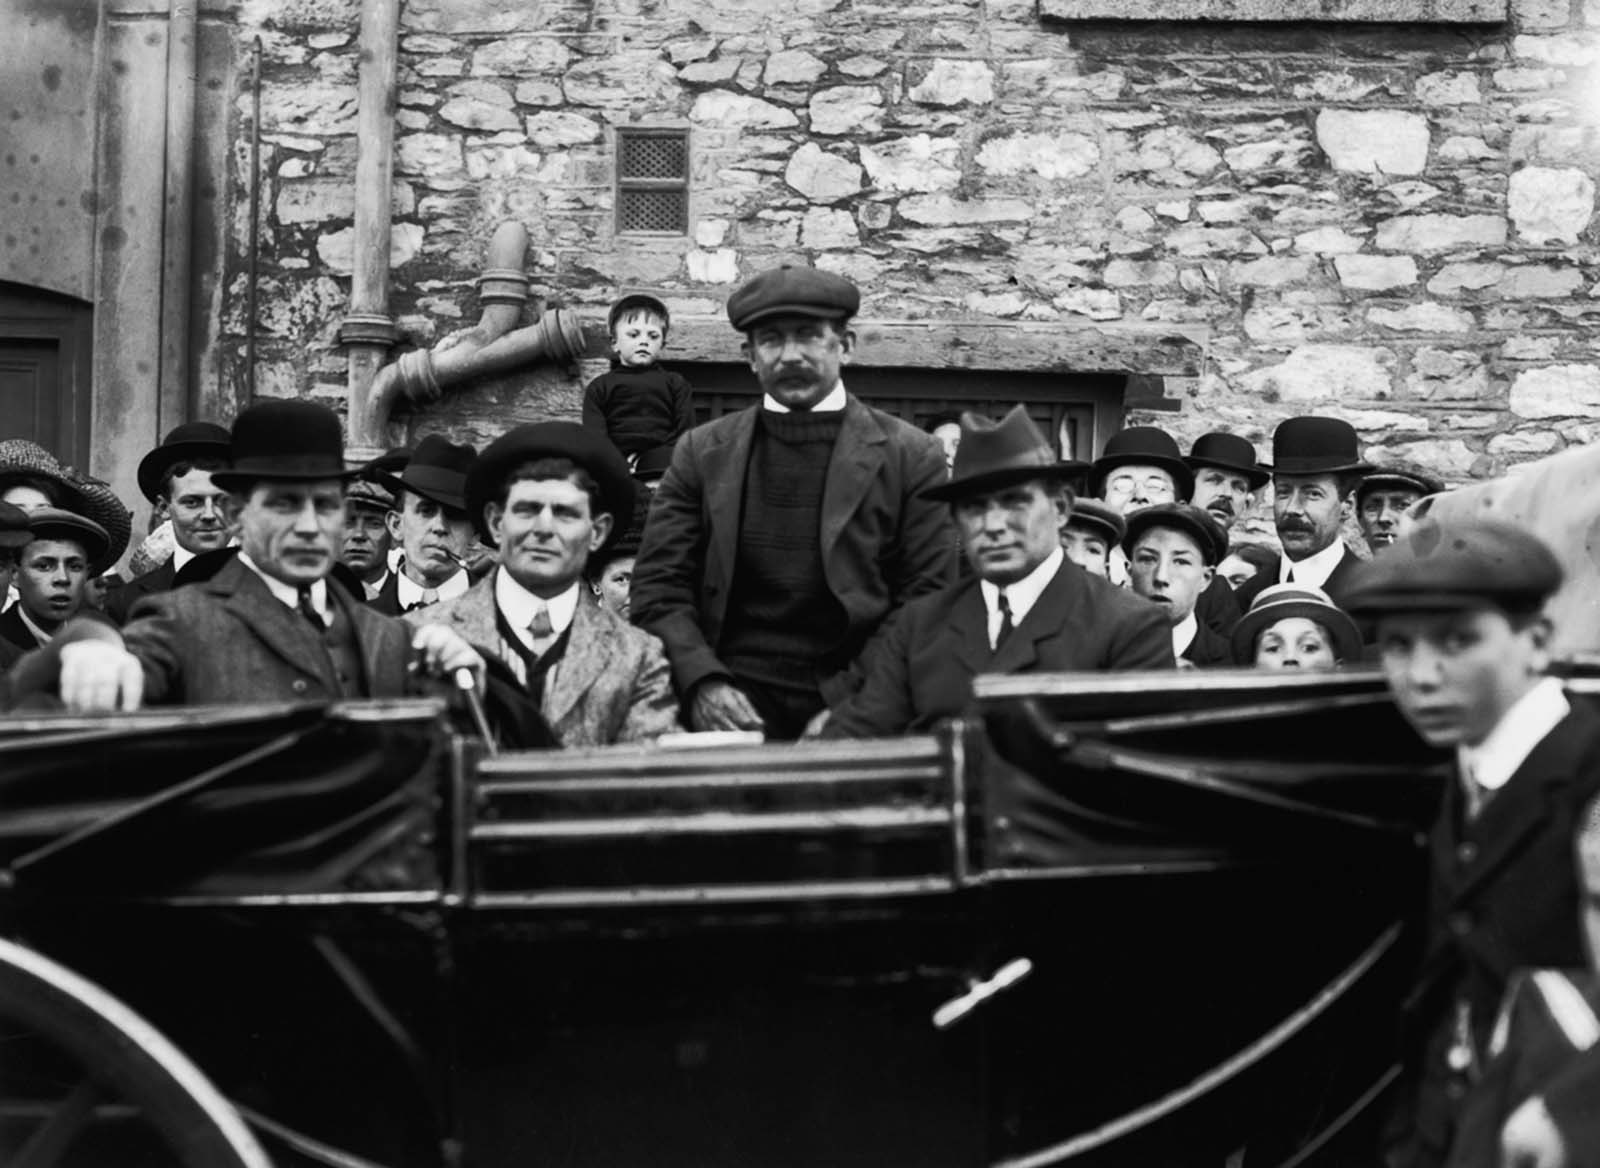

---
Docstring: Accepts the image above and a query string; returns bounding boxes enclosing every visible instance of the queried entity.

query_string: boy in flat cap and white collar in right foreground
[1344,518,1600,1168]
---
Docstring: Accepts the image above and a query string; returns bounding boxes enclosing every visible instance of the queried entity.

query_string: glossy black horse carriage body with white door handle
[0,674,1465,1168]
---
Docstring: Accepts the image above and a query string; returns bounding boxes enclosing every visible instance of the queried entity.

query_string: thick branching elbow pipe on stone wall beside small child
[346,222,586,462]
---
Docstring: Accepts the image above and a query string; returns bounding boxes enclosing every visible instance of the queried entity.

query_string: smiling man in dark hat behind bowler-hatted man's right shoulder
[106,422,229,624]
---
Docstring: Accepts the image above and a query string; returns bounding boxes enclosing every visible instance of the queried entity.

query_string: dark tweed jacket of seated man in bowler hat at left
[122,558,413,706]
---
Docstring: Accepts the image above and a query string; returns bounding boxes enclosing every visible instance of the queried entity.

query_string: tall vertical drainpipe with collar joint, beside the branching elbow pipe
[339,0,400,458]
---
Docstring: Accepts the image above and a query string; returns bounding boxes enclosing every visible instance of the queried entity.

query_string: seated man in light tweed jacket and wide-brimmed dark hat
[406,422,680,746]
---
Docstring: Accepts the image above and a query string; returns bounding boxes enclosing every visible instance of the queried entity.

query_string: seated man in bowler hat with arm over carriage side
[46,400,483,709]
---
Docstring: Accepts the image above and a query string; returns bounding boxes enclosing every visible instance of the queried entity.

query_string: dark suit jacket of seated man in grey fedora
[824,560,1173,738]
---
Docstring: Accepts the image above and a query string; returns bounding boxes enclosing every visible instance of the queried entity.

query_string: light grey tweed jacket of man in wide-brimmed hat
[405,573,682,746]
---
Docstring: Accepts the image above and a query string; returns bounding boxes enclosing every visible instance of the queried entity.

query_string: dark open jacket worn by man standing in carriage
[632,395,955,704]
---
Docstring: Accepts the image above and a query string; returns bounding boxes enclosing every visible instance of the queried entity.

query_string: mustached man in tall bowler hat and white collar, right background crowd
[1237,416,1371,610]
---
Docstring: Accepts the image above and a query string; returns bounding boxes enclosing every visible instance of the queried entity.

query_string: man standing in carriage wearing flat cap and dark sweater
[632,267,955,739]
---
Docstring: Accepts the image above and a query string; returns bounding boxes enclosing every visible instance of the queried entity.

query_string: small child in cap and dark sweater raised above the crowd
[584,294,694,470]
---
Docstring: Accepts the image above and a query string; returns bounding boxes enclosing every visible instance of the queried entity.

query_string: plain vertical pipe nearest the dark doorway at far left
[154,0,198,428]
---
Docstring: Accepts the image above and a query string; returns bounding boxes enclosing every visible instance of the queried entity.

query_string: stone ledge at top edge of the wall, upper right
[1038,0,1510,24]
